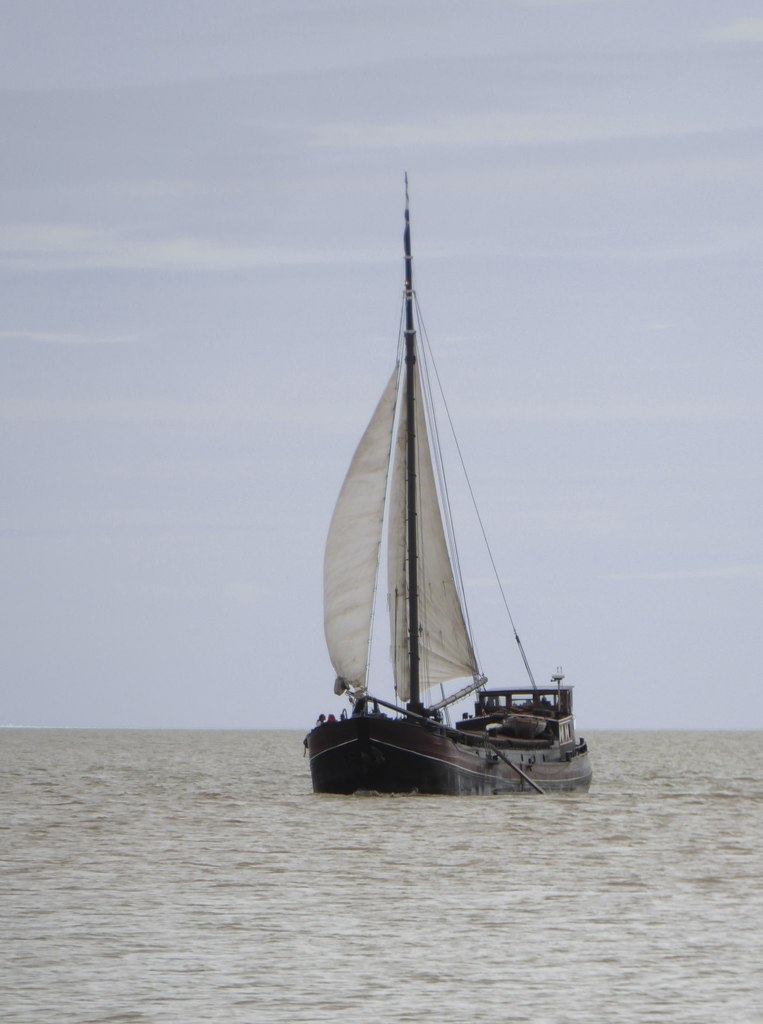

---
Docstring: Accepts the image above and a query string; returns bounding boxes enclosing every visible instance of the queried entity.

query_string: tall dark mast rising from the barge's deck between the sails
[402,174,423,713]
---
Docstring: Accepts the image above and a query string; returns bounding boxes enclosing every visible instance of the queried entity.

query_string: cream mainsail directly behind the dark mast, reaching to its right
[387,366,478,700]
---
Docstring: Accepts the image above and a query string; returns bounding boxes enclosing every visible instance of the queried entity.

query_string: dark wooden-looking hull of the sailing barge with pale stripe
[305,716,591,796]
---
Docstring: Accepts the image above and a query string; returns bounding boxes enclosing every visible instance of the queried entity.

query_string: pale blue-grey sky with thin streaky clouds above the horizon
[0,0,763,734]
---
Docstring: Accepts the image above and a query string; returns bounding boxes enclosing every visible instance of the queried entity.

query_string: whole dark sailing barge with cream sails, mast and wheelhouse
[305,188,591,795]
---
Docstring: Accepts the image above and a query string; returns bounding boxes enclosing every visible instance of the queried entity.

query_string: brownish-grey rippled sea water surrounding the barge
[0,729,763,1024]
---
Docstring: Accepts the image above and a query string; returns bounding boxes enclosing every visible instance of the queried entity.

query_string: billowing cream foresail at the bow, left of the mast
[324,370,397,692]
